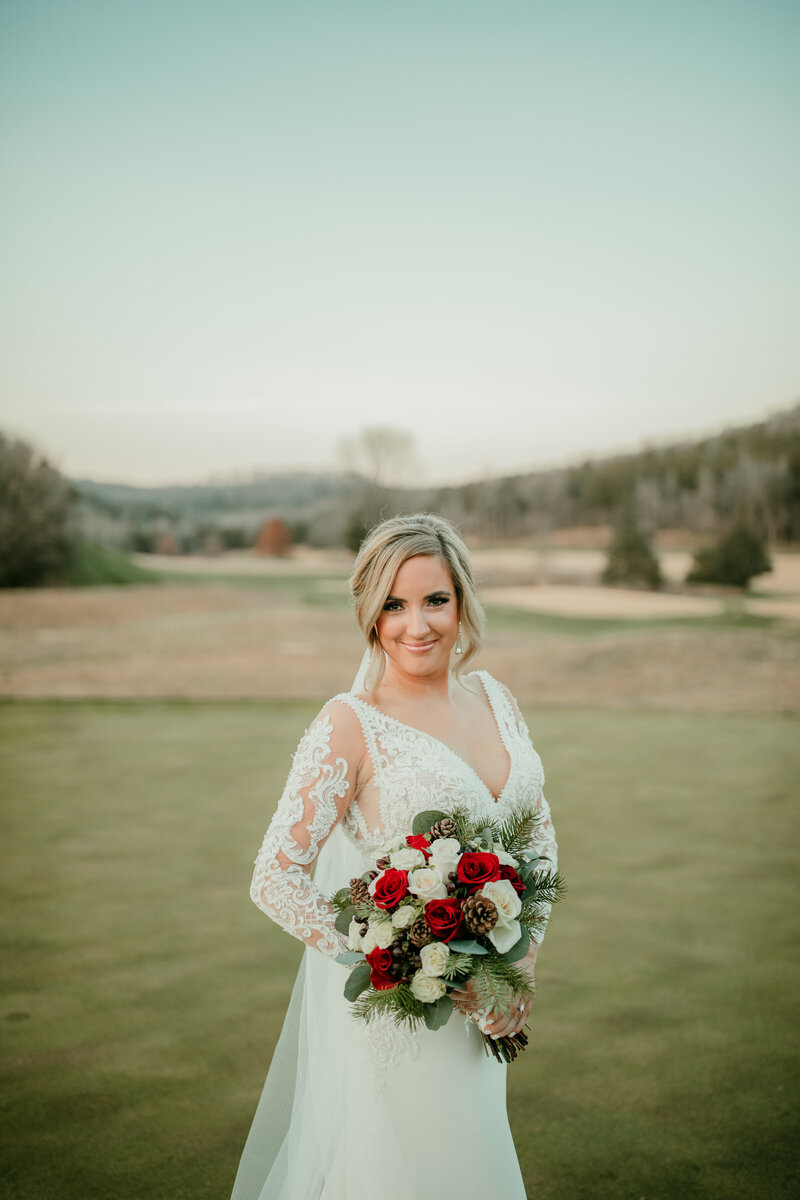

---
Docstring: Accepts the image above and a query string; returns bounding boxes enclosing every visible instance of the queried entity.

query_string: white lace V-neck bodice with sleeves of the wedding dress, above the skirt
[251,671,558,958]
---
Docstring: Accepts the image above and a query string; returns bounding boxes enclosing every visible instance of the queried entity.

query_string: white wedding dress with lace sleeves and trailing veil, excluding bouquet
[231,671,557,1200]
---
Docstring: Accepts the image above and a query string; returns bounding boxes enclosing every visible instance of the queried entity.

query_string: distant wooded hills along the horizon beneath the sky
[72,404,800,552]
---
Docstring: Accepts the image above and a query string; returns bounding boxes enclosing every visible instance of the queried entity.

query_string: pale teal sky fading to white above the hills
[0,0,800,484]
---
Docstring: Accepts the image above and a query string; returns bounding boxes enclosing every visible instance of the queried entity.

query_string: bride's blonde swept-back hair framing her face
[350,512,483,691]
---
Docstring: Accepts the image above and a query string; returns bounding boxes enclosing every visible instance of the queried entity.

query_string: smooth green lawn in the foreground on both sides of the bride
[0,703,800,1200]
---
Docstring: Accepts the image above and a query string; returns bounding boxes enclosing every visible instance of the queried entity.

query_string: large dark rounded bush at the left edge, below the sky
[0,433,74,588]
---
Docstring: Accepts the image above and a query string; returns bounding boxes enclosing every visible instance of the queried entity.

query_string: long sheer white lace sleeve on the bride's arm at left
[249,706,356,958]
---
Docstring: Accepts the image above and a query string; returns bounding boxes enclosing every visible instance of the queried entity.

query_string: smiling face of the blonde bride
[375,554,458,676]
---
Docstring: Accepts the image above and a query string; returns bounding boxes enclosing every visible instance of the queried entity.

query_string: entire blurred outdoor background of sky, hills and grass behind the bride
[0,0,800,1200]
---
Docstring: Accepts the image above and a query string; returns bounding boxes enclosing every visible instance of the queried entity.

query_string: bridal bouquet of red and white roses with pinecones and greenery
[331,808,565,1062]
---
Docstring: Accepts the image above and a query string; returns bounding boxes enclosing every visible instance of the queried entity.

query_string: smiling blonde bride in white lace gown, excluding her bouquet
[231,514,557,1200]
